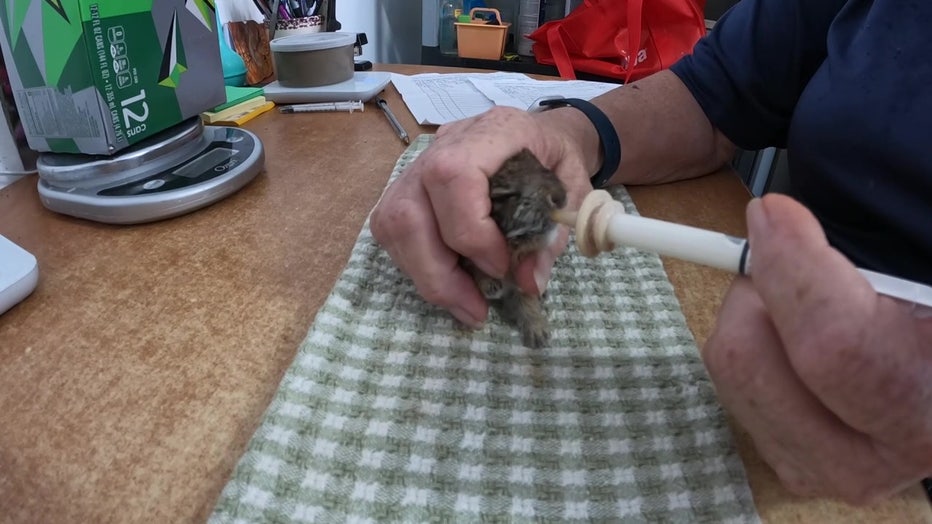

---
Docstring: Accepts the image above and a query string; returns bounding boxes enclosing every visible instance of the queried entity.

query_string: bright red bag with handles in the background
[528,0,706,83]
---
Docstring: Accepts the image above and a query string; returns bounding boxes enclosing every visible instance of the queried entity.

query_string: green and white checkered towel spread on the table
[210,136,759,523]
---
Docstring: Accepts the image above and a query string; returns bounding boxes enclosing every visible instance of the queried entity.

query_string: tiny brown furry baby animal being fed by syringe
[460,149,566,348]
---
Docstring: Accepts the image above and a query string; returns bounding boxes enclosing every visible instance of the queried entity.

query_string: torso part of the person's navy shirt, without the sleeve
[787,0,932,283]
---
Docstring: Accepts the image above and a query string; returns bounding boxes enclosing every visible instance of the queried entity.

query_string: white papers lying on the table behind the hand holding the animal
[392,72,620,125]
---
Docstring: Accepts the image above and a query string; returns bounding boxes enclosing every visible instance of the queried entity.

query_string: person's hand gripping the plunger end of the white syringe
[702,195,932,503]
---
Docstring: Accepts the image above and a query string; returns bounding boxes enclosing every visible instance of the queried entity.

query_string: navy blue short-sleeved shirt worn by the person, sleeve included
[671,0,932,284]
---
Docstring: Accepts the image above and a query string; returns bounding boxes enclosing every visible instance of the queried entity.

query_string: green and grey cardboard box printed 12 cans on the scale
[0,0,226,155]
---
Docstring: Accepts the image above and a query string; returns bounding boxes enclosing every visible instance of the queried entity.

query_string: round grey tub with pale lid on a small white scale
[269,33,356,87]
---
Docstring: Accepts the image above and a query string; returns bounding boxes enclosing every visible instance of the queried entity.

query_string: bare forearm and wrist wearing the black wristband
[541,71,734,184]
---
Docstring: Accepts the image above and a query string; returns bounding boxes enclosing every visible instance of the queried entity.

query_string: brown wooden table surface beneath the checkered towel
[0,66,932,522]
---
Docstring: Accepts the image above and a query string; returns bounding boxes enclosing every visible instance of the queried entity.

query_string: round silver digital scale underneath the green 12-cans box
[36,117,265,224]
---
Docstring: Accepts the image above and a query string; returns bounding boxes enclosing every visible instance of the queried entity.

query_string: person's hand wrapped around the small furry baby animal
[370,108,591,327]
